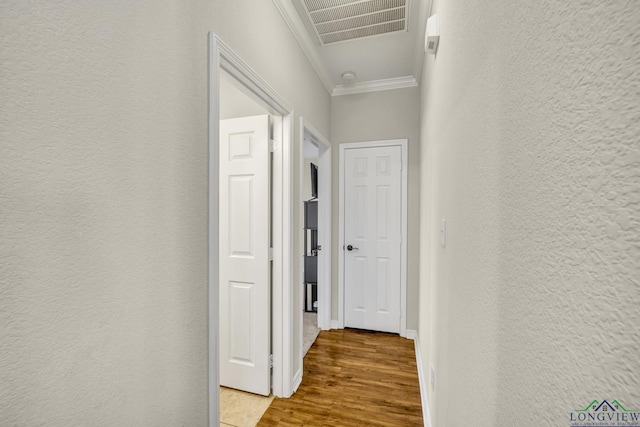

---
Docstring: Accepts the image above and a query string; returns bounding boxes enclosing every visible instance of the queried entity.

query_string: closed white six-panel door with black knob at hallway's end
[343,146,402,333]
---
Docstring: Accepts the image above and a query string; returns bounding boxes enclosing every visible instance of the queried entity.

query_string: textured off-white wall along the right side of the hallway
[419,0,640,427]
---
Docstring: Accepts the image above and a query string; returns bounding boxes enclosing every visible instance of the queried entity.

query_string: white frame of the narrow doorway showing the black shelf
[299,117,332,332]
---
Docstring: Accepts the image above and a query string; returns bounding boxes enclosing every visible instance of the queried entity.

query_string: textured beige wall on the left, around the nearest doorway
[0,0,330,426]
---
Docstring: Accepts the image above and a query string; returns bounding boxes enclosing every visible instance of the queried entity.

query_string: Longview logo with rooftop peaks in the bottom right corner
[569,399,640,427]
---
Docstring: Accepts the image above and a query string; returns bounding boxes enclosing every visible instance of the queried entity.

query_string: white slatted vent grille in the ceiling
[301,0,409,44]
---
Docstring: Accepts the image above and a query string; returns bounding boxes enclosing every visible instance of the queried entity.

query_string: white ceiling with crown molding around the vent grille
[273,0,431,96]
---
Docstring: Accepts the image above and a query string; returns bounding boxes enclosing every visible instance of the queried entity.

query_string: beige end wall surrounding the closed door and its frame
[331,87,420,330]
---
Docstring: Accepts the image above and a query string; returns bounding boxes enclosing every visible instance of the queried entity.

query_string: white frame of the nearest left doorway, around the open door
[208,32,294,427]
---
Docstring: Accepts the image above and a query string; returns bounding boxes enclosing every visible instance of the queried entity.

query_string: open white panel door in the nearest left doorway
[220,115,271,396]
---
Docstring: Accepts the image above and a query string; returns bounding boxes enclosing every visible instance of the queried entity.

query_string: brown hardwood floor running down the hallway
[258,329,423,427]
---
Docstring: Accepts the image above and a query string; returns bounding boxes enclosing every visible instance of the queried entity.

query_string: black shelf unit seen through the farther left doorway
[304,199,318,312]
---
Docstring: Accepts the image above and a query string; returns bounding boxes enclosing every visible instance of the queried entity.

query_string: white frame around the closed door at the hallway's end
[338,139,409,338]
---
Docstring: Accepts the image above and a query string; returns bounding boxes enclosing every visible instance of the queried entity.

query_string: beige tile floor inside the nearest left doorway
[220,387,273,427]
